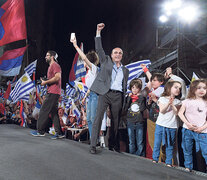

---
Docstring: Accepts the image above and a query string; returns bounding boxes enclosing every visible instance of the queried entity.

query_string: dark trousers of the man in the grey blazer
[91,91,123,149]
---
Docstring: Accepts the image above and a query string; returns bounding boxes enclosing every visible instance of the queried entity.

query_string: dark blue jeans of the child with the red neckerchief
[127,122,145,156]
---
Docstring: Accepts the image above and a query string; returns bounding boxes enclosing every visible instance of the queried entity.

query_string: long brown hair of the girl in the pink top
[187,79,207,101]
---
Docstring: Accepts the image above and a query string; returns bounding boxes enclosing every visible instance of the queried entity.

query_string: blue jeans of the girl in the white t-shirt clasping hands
[152,124,176,165]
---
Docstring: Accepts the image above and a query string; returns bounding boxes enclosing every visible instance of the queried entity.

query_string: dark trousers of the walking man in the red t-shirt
[37,94,62,134]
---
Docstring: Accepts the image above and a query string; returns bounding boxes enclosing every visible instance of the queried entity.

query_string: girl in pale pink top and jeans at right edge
[178,79,207,171]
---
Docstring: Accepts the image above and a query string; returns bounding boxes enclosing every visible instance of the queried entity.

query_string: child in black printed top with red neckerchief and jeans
[123,78,146,156]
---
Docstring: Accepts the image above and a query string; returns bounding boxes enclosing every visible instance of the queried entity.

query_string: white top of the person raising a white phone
[85,63,98,89]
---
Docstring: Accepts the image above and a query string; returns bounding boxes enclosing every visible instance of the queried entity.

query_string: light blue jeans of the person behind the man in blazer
[86,91,98,136]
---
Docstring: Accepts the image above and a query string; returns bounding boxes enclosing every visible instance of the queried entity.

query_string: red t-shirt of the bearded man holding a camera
[47,62,62,95]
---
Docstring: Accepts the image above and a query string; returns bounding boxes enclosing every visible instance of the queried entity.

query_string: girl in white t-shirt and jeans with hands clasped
[152,81,181,166]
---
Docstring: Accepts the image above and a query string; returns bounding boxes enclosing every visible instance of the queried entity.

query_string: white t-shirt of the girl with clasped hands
[156,97,180,128]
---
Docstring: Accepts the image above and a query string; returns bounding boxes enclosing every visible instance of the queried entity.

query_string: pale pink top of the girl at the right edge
[182,99,207,133]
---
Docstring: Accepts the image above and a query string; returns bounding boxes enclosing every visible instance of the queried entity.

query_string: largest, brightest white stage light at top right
[178,5,198,23]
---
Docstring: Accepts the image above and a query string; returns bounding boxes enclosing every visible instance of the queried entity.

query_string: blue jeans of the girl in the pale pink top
[182,128,207,170]
